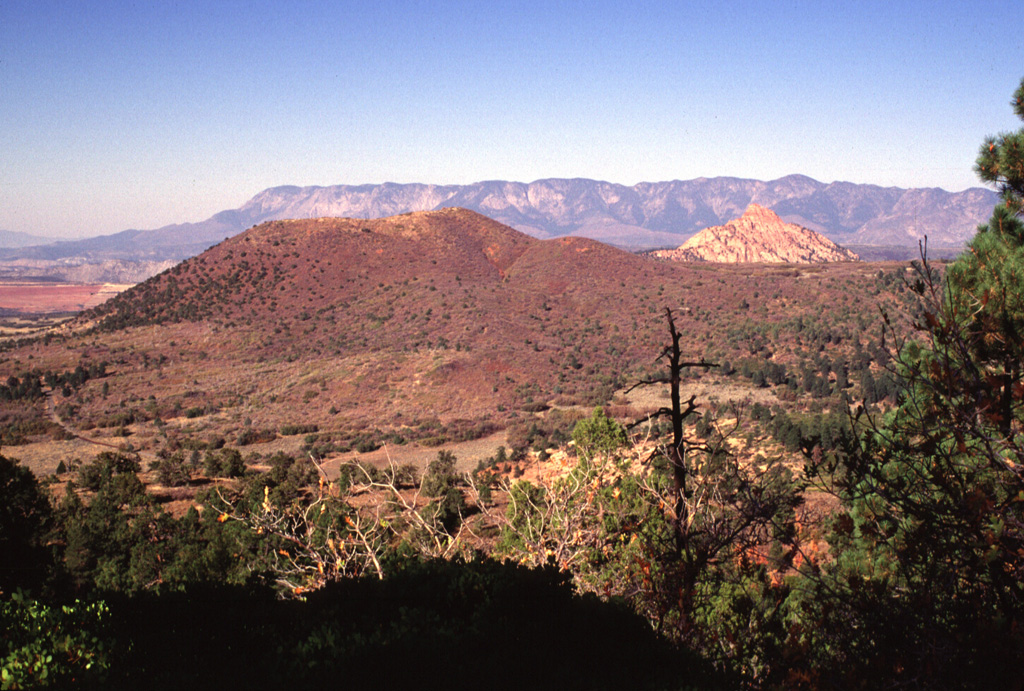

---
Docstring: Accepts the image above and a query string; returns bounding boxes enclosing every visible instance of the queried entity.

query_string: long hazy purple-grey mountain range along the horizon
[0,175,997,276]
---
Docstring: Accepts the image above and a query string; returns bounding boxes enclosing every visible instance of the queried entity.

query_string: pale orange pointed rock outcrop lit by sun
[653,204,860,264]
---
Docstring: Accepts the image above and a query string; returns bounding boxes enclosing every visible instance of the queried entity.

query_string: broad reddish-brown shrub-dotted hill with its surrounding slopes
[0,210,925,487]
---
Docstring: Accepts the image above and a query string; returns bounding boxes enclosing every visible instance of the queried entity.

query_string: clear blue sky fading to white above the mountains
[0,0,1024,235]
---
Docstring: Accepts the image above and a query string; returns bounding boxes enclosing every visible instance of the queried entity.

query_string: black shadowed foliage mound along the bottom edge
[6,560,731,689]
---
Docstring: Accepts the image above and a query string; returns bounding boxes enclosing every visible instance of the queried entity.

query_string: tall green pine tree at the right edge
[794,74,1024,688]
